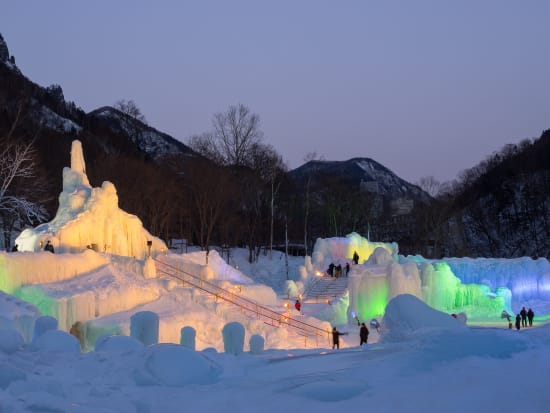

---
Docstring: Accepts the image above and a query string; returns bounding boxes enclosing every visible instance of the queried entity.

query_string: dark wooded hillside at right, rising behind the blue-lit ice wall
[446,130,550,257]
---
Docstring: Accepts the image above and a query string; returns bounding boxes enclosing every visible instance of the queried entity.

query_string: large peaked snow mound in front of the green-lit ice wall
[381,294,466,342]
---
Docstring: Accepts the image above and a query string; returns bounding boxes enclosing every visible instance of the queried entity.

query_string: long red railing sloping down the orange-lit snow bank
[154,258,330,346]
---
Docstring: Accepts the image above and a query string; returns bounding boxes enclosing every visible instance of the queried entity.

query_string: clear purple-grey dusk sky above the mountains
[0,0,550,182]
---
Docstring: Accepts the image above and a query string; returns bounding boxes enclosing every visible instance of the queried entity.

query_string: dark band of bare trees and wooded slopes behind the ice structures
[0,50,550,260]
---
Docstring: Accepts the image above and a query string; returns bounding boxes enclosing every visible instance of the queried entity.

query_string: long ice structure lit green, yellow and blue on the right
[312,233,550,322]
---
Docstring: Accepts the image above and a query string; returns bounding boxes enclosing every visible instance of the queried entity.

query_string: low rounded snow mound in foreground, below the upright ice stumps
[135,344,220,386]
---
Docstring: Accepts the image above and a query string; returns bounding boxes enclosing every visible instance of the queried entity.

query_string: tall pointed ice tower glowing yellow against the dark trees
[15,141,166,259]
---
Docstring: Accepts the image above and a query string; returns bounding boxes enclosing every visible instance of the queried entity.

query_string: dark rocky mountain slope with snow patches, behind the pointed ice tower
[0,31,199,166]
